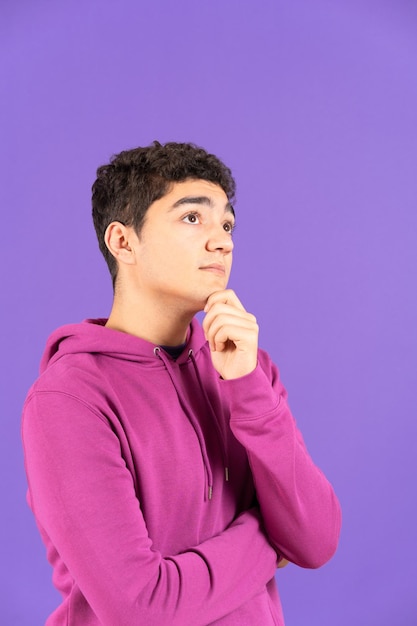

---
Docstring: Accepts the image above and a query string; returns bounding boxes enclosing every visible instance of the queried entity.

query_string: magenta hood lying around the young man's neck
[40,319,206,374]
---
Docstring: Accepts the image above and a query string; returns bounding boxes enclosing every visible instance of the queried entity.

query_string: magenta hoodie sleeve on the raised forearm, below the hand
[221,351,341,568]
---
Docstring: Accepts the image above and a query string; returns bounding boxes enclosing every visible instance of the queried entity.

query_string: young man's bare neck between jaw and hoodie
[106,293,195,346]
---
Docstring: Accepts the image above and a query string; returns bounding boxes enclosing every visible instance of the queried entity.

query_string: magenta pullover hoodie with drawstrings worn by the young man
[22,320,341,626]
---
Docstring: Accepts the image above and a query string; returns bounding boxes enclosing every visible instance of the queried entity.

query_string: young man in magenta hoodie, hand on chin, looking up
[23,142,340,626]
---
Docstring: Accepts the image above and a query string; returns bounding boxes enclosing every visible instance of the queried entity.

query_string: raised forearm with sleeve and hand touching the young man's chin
[203,289,341,567]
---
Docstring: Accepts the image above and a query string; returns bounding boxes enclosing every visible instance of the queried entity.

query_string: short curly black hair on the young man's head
[92,141,236,286]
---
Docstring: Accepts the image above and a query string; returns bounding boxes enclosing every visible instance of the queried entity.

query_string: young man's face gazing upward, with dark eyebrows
[128,180,234,313]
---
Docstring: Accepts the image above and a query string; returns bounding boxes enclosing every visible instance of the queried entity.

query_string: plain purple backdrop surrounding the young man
[0,0,417,626]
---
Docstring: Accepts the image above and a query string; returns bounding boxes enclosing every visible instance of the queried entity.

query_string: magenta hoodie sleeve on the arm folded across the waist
[22,392,277,626]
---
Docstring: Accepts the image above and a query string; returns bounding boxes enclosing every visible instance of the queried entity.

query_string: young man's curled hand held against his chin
[203,289,259,380]
